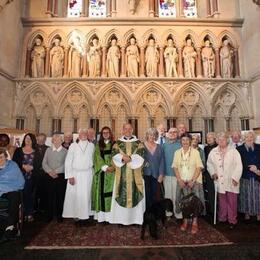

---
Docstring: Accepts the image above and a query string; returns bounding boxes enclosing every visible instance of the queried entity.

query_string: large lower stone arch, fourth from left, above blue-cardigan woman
[133,82,171,116]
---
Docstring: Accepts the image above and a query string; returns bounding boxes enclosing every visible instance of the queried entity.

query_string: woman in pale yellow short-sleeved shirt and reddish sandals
[172,133,204,234]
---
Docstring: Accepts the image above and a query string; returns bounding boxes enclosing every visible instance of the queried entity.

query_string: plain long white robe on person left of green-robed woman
[62,141,95,219]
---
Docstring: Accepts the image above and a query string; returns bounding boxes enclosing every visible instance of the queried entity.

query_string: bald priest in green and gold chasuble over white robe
[109,124,145,225]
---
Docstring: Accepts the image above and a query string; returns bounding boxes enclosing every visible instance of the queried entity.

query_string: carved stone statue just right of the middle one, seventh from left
[145,39,159,77]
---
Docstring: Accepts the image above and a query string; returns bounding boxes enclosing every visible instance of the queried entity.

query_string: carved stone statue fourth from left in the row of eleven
[88,38,101,78]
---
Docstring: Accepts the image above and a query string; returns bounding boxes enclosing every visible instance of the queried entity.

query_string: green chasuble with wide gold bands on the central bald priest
[112,139,144,208]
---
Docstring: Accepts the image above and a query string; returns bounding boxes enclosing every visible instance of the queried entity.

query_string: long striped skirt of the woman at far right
[238,178,260,216]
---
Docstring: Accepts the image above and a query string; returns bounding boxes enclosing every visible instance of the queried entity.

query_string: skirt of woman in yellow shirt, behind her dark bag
[175,182,206,215]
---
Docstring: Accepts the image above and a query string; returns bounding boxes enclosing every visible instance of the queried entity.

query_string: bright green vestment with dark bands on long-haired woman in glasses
[91,142,115,212]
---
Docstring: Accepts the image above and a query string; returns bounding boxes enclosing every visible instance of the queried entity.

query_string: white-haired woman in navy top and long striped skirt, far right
[237,131,260,223]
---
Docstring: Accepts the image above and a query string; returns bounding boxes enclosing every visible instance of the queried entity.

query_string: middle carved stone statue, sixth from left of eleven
[126,38,140,77]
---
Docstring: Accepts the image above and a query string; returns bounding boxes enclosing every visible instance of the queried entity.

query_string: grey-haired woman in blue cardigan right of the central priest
[143,128,164,208]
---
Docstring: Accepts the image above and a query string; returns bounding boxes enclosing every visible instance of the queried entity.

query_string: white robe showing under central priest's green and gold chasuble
[109,137,145,225]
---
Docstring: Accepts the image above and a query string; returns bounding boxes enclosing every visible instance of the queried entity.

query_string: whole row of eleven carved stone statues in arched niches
[31,36,233,78]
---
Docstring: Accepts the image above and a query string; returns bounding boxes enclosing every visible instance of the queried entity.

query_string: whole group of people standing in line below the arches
[0,123,260,240]
